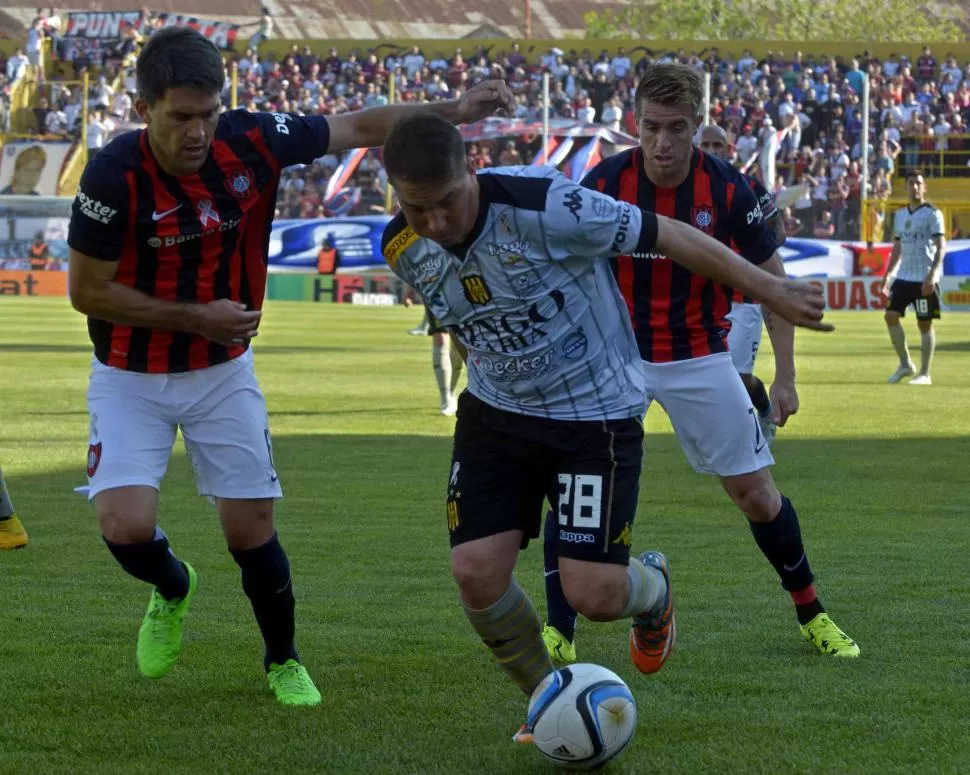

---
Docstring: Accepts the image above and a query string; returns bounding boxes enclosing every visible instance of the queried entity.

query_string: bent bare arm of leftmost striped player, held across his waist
[68,248,262,346]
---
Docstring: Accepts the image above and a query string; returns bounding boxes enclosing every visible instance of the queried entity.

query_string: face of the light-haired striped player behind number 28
[637,100,697,185]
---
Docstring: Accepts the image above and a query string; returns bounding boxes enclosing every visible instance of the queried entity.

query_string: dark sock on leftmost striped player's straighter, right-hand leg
[232,533,300,670]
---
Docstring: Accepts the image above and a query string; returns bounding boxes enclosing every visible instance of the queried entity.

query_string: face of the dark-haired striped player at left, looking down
[135,87,221,175]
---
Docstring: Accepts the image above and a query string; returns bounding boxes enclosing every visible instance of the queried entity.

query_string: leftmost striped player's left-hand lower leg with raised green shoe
[94,485,198,678]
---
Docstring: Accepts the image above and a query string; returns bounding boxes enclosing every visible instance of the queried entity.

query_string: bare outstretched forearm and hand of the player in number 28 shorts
[643,212,834,331]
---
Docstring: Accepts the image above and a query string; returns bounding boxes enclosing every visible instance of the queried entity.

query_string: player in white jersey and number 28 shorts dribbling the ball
[374,115,827,742]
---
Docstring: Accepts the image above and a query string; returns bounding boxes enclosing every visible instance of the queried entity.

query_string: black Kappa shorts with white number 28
[447,391,643,565]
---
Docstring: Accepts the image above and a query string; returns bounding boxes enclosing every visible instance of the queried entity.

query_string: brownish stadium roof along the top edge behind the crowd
[0,0,629,40]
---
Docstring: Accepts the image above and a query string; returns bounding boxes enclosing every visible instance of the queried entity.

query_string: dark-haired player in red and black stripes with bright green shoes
[68,28,511,705]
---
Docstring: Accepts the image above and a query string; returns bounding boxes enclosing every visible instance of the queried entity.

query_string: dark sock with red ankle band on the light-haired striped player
[748,495,825,624]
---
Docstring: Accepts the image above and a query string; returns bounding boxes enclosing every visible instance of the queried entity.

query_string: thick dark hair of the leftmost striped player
[135,27,226,105]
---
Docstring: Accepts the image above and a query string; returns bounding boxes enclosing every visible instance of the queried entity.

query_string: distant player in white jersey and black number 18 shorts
[880,170,946,385]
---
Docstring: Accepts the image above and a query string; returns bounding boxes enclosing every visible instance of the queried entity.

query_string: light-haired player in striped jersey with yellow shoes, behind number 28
[544,64,859,661]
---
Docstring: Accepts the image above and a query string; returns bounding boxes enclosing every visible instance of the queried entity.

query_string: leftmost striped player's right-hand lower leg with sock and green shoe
[217,498,321,705]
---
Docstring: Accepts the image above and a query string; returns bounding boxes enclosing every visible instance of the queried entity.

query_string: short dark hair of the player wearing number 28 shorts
[384,111,467,183]
